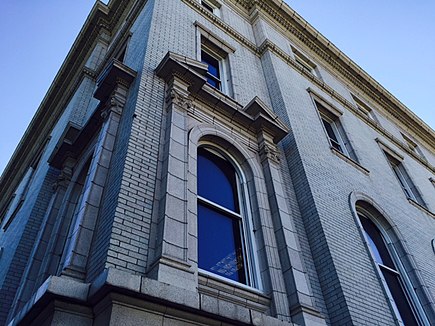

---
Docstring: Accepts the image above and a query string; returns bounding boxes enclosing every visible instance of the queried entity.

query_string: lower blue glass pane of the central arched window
[198,203,246,284]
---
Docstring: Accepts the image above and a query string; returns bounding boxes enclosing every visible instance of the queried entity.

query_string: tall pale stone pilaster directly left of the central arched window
[149,76,197,291]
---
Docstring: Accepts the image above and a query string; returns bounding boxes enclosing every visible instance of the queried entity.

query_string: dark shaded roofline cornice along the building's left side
[0,0,147,222]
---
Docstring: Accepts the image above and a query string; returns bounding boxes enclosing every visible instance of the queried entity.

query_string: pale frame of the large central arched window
[196,142,263,291]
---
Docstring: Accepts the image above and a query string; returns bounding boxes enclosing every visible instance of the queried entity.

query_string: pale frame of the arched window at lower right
[356,207,430,326]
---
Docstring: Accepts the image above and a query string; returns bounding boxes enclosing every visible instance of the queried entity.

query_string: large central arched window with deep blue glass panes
[197,147,256,286]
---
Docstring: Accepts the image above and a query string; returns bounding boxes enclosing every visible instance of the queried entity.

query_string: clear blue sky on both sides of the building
[0,0,435,173]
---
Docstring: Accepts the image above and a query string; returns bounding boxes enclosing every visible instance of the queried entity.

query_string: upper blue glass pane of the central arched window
[198,148,240,213]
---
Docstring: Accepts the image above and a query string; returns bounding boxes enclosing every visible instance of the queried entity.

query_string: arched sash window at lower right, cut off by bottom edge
[358,213,429,325]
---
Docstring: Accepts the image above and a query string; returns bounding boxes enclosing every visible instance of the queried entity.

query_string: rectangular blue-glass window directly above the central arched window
[200,37,231,95]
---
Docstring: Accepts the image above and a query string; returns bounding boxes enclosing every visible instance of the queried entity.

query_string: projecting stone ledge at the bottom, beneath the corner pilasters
[9,268,293,326]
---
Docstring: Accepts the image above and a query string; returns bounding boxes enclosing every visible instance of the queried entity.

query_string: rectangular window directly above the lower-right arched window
[315,101,358,162]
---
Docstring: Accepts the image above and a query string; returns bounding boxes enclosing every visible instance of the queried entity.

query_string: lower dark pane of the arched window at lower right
[381,268,418,325]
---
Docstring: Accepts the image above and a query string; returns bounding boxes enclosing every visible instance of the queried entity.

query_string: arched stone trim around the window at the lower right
[349,192,435,325]
